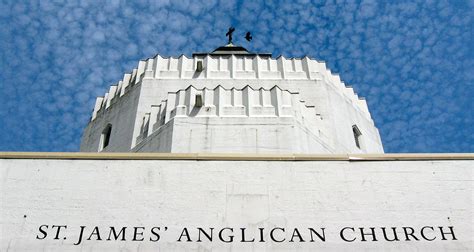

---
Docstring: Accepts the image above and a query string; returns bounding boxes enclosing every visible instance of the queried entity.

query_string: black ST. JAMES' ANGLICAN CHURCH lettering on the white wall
[36,224,457,246]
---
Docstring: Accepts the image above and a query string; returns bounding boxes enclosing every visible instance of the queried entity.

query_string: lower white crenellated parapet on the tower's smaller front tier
[137,85,322,142]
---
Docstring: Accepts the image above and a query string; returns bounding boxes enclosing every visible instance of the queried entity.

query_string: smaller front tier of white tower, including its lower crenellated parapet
[132,86,335,154]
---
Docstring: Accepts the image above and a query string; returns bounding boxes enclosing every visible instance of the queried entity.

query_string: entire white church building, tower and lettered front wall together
[0,29,474,251]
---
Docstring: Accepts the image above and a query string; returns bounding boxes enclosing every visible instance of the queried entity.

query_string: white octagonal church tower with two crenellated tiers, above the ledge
[81,43,383,154]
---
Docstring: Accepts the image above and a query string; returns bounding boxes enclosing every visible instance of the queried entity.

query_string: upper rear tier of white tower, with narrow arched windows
[81,55,383,153]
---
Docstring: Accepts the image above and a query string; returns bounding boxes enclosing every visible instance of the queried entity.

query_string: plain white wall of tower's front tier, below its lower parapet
[132,117,334,154]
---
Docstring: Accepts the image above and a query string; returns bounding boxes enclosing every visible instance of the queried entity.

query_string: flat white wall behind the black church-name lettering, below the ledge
[0,159,474,251]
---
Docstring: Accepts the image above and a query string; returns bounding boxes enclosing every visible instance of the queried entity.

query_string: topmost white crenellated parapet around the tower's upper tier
[91,54,370,120]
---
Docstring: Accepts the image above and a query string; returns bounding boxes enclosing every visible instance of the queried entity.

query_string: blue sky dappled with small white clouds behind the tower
[0,0,474,152]
